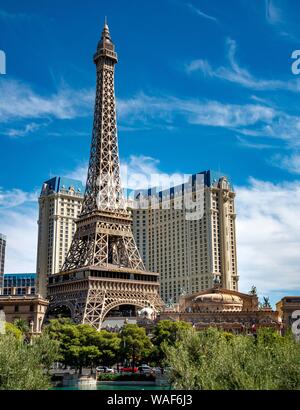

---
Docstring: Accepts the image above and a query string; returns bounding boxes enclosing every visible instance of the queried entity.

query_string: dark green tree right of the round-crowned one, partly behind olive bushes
[152,320,191,365]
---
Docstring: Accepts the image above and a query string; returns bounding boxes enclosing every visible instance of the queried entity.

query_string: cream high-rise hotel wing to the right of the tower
[132,171,238,303]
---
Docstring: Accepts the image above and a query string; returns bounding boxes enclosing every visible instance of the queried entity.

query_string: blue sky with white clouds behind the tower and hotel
[0,0,300,308]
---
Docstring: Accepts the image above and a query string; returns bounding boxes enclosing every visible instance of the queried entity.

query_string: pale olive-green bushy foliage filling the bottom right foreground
[166,328,300,390]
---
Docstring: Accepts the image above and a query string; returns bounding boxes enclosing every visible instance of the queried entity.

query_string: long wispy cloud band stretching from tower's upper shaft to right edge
[119,89,300,148]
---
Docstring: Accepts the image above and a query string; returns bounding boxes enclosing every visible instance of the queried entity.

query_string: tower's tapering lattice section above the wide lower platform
[62,25,145,271]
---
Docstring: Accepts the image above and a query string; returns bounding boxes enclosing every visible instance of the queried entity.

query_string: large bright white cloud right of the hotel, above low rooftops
[236,179,300,294]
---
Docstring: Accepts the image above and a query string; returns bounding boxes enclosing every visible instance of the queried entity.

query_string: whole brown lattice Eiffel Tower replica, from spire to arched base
[47,20,163,330]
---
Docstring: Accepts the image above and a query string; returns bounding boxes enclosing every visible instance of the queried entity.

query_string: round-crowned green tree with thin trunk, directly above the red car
[120,324,152,371]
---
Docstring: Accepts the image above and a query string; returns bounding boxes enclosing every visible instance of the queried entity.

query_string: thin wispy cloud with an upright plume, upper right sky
[185,39,300,93]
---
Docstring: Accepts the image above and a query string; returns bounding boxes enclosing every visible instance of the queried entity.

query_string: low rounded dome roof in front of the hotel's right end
[193,293,243,311]
